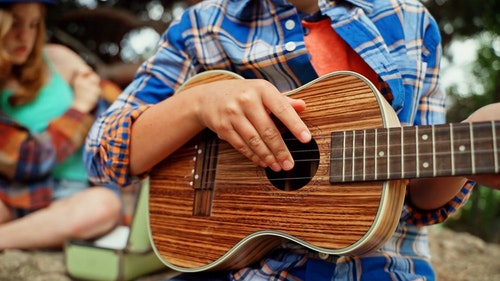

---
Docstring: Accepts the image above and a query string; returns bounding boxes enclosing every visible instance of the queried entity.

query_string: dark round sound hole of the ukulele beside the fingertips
[266,132,319,191]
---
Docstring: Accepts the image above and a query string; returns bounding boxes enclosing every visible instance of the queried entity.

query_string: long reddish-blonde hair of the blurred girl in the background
[0,4,46,105]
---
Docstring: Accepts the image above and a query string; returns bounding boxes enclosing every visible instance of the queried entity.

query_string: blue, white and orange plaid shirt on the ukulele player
[86,0,472,280]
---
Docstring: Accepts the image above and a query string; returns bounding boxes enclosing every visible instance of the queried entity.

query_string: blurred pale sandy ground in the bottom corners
[0,227,500,281]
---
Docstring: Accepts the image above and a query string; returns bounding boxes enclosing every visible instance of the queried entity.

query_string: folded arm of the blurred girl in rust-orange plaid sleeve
[0,109,93,181]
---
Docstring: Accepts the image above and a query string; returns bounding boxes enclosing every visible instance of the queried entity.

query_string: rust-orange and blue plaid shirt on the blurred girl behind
[0,109,93,209]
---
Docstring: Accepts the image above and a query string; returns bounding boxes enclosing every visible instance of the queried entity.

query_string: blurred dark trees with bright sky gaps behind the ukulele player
[48,0,500,242]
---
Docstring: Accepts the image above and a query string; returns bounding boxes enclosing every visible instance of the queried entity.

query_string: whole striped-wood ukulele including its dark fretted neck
[149,71,500,272]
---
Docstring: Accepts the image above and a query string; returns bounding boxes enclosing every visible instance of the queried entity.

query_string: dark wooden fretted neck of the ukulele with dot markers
[330,121,500,183]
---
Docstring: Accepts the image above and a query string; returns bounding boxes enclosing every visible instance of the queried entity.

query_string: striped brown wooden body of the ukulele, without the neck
[149,71,405,272]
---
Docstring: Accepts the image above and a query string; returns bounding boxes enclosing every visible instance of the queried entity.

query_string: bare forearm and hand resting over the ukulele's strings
[130,79,310,174]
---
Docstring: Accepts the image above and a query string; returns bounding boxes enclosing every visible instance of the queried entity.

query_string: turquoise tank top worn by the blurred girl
[0,60,87,181]
